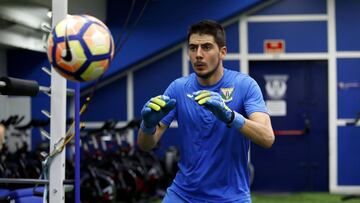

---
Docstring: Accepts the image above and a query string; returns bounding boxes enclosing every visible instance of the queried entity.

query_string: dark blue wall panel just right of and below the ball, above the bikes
[81,77,127,121]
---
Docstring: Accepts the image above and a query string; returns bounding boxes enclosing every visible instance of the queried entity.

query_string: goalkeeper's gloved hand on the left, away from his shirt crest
[140,95,176,134]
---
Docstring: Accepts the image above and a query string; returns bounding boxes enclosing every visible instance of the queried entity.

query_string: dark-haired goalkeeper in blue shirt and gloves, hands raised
[138,20,274,203]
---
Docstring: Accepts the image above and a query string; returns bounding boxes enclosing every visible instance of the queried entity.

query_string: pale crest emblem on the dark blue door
[264,75,289,99]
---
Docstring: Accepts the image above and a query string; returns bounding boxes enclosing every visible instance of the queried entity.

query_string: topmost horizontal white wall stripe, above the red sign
[248,14,328,23]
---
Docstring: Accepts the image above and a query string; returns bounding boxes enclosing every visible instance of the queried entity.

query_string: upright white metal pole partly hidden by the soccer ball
[49,0,68,203]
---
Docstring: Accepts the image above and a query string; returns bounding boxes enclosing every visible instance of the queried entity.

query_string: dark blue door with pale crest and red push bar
[249,61,329,191]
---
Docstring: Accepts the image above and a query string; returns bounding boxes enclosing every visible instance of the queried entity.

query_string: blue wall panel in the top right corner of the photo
[336,0,360,51]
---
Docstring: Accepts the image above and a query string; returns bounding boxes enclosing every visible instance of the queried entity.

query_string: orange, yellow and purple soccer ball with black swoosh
[47,15,114,82]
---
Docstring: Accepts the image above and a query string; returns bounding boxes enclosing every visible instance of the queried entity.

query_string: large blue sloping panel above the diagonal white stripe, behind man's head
[106,0,261,82]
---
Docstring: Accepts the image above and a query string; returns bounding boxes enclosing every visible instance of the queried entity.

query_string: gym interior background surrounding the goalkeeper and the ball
[0,0,360,203]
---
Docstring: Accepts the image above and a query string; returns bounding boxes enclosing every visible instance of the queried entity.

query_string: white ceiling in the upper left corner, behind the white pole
[0,0,106,52]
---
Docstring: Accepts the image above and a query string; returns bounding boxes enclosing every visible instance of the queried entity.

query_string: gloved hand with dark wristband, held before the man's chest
[193,90,245,129]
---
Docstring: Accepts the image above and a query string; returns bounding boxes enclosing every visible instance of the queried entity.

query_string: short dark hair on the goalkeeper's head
[188,20,226,48]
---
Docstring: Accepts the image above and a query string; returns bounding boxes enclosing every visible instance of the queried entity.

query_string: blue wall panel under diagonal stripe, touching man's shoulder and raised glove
[134,50,182,117]
